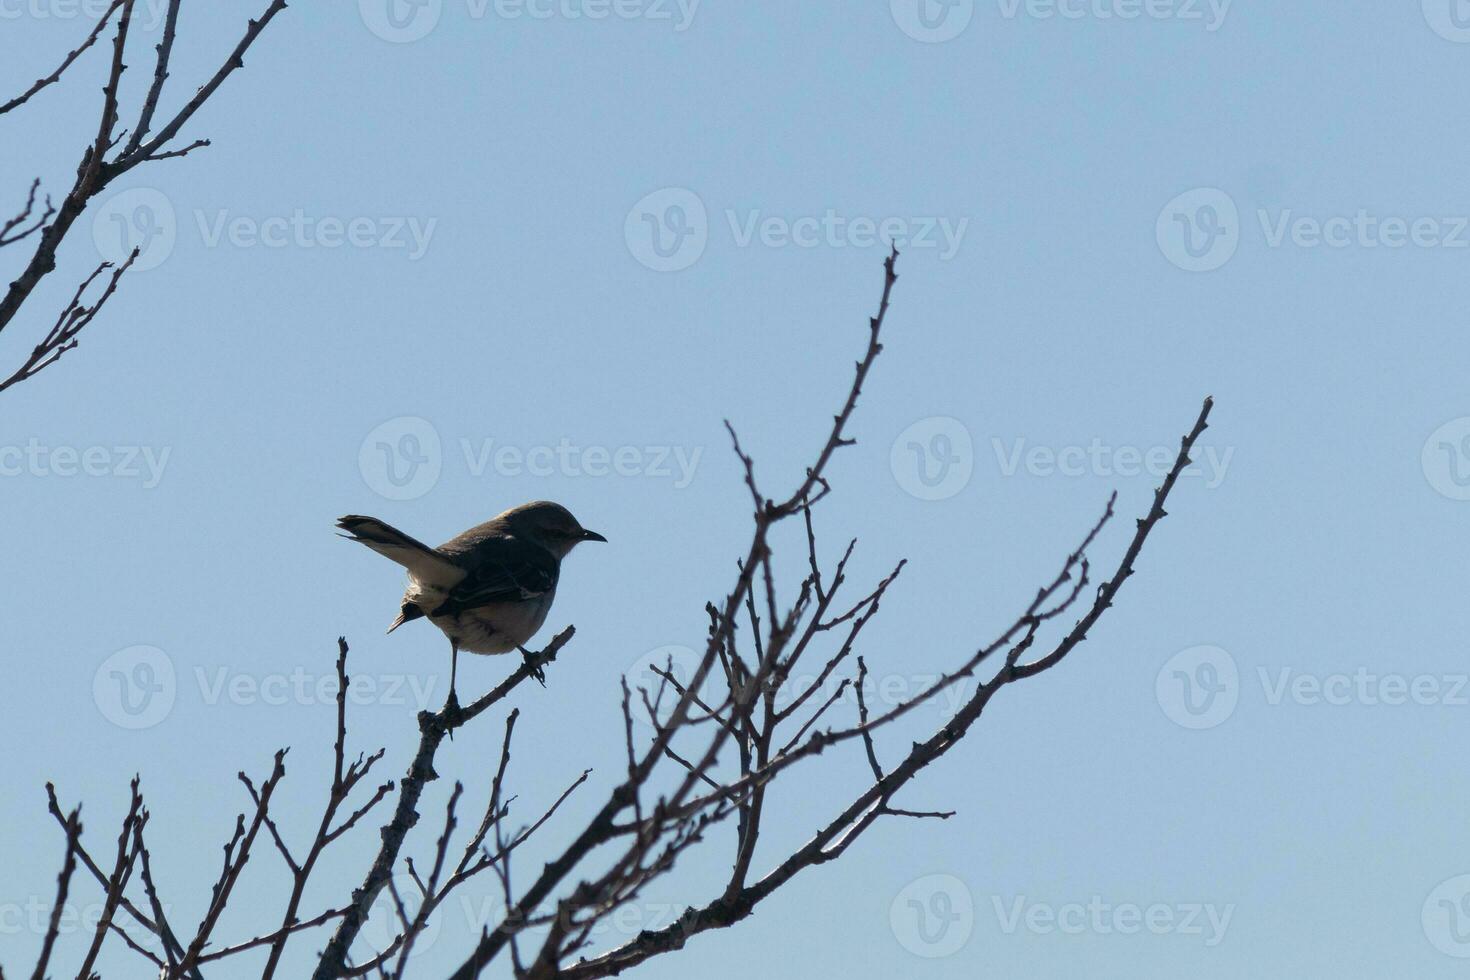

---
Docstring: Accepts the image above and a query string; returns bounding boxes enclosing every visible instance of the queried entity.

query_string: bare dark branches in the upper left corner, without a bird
[0,0,287,391]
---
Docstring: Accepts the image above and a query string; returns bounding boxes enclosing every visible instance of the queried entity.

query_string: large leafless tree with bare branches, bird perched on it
[5,243,1211,980]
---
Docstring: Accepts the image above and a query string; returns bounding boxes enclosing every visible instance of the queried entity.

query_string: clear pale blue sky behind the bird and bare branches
[0,0,1470,980]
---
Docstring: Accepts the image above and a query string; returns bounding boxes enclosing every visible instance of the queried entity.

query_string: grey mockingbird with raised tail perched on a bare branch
[337,500,607,705]
